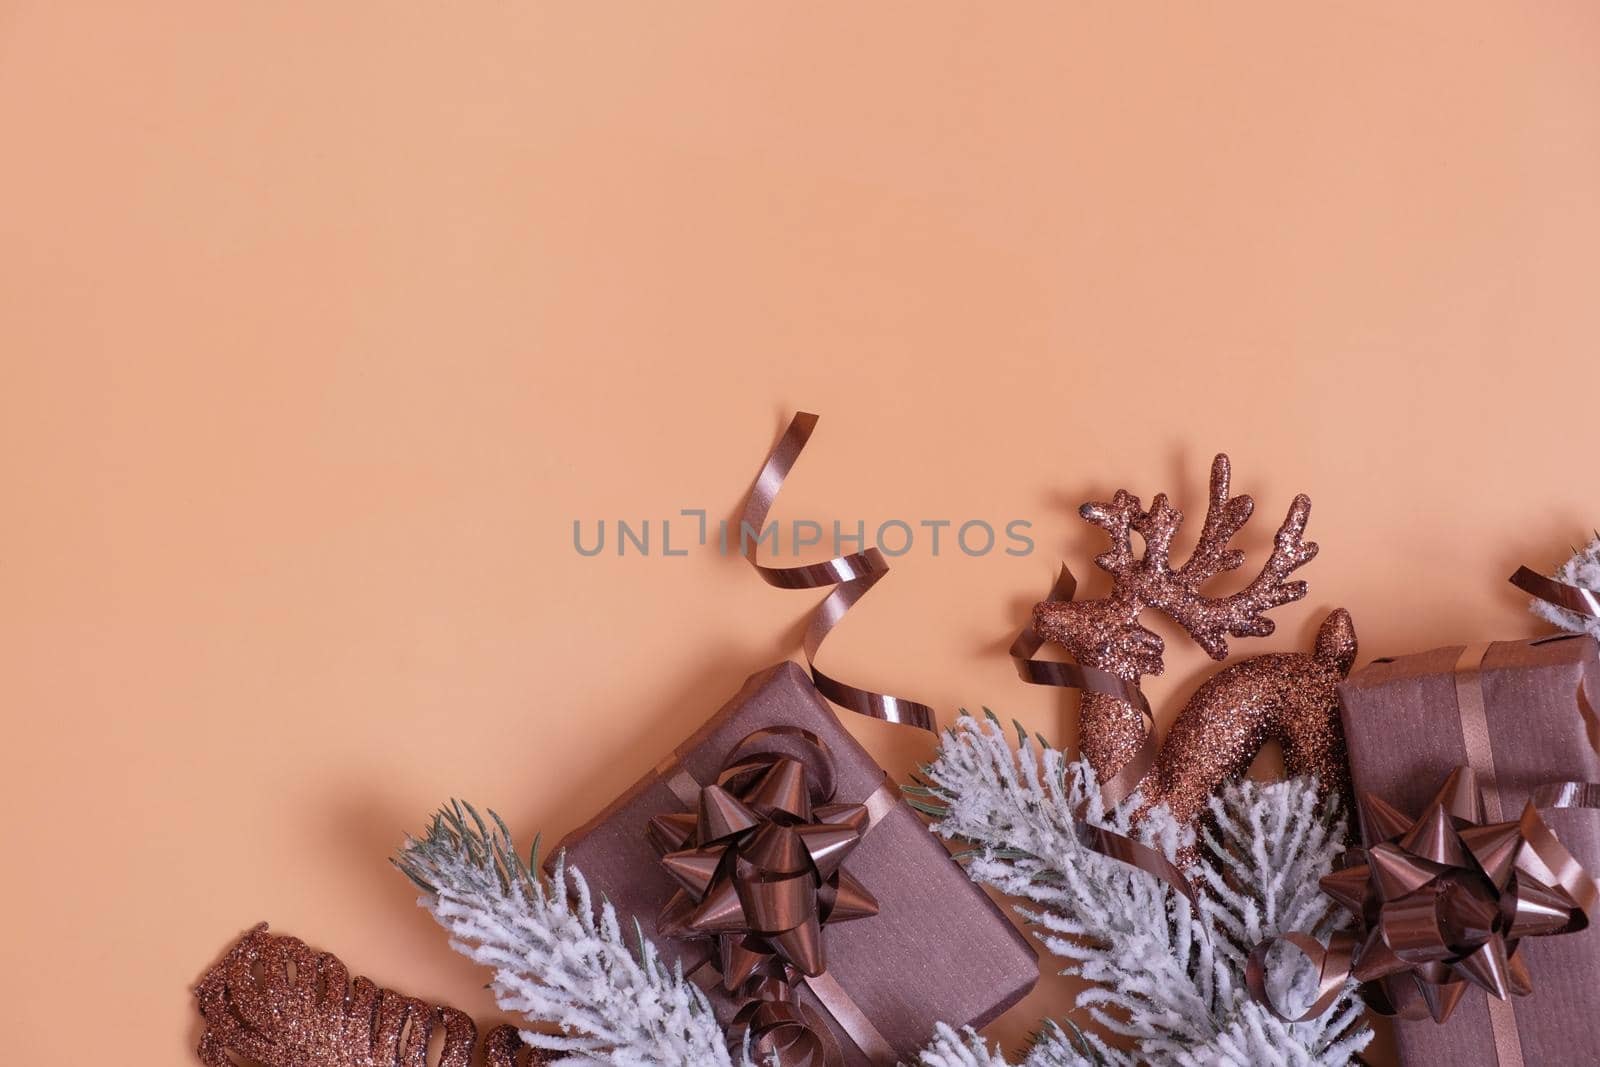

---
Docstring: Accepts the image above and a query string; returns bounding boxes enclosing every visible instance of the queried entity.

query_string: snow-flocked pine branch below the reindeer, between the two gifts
[907,715,1371,1067]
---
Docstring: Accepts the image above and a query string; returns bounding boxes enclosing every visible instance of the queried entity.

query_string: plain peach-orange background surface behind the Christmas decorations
[0,0,1600,1065]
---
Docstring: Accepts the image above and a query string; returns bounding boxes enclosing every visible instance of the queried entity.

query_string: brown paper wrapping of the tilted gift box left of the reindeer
[557,662,1038,1067]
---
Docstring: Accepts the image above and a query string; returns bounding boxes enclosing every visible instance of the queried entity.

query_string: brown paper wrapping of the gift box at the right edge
[1339,635,1600,1067]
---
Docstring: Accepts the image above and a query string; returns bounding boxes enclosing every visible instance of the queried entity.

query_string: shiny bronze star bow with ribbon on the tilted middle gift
[648,726,893,1067]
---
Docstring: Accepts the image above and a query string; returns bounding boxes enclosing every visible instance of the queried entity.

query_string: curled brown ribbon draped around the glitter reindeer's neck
[1011,563,1198,907]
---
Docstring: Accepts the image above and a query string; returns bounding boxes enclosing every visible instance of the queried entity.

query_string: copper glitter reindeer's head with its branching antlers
[1034,456,1317,683]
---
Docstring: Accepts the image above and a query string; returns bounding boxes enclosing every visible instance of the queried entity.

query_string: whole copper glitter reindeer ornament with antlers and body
[1034,456,1355,838]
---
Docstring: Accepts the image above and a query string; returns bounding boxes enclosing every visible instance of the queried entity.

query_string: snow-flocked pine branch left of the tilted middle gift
[395,803,755,1067]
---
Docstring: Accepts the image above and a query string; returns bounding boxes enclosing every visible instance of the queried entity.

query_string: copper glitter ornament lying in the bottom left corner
[195,923,547,1067]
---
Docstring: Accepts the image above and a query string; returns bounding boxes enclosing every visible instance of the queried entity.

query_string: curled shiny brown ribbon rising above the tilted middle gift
[739,411,938,733]
